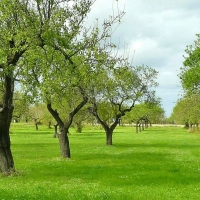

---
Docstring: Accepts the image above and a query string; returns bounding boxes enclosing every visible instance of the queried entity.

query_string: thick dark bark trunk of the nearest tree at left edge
[0,36,27,174]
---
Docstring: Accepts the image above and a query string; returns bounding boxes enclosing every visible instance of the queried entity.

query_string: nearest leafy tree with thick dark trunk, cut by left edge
[0,0,35,174]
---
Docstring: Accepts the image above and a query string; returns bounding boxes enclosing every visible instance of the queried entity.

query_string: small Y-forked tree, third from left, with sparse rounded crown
[89,63,157,145]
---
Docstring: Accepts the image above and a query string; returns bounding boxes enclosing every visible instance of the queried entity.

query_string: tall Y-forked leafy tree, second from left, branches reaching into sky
[20,0,124,158]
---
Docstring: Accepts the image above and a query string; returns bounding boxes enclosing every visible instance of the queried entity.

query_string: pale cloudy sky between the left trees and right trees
[88,0,200,117]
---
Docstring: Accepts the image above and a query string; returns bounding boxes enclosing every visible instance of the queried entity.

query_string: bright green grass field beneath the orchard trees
[0,124,200,200]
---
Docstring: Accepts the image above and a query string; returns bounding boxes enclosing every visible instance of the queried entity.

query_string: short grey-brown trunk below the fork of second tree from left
[58,127,71,158]
